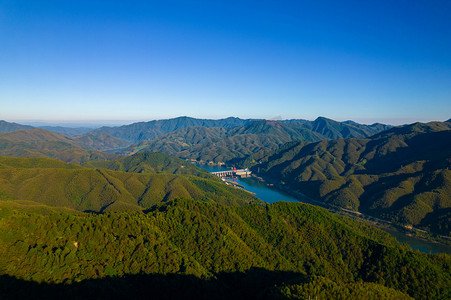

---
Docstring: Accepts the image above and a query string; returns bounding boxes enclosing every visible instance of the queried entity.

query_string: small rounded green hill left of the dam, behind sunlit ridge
[84,152,214,178]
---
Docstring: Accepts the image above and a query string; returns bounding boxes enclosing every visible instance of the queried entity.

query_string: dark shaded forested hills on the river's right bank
[253,122,451,235]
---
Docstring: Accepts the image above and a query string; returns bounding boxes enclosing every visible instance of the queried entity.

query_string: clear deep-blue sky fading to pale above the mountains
[0,0,451,124]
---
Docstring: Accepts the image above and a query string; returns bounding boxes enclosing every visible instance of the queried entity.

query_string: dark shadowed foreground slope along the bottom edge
[0,268,413,300]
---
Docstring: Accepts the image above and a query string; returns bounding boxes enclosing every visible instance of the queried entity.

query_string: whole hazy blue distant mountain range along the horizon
[0,117,391,164]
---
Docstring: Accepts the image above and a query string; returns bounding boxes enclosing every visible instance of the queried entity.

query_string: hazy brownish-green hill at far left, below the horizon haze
[0,129,120,164]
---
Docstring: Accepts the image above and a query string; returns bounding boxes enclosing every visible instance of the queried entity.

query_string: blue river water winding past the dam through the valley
[199,165,451,254]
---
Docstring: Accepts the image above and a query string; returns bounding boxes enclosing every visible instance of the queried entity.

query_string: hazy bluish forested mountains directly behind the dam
[124,118,388,164]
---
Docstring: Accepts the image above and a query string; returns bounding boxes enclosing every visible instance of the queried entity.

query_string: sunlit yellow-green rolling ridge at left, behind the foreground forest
[0,155,260,212]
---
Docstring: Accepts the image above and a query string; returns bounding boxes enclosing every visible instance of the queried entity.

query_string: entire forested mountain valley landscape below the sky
[0,117,451,299]
